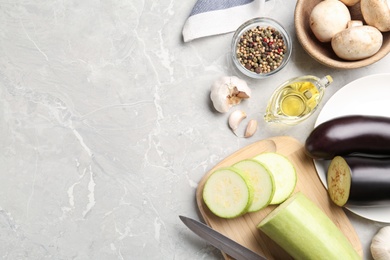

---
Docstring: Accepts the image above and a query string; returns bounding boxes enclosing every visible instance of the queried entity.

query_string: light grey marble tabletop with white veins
[0,0,390,260]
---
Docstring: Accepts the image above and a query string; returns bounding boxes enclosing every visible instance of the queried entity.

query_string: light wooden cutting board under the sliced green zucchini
[196,136,363,260]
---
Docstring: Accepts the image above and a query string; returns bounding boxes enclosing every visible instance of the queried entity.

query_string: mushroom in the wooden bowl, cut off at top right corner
[360,0,390,32]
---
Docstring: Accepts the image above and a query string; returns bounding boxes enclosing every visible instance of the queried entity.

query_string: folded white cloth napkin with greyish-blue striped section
[182,0,264,42]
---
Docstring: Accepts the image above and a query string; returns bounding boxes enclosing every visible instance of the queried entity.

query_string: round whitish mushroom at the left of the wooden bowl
[310,0,351,42]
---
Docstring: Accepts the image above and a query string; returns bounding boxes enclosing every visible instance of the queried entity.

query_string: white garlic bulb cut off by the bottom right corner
[371,226,390,260]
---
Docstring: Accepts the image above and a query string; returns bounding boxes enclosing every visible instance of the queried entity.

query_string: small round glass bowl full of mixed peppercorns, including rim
[231,17,292,79]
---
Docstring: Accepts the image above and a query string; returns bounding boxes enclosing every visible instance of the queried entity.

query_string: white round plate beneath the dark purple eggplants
[314,74,390,223]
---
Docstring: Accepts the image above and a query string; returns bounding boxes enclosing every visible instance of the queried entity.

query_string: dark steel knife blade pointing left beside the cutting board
[179,216,266,260]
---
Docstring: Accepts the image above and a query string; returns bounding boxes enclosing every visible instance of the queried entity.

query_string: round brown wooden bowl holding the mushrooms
[294,0,390,69]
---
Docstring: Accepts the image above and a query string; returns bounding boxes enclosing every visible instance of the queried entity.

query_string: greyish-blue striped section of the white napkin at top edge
[190,0,254,16]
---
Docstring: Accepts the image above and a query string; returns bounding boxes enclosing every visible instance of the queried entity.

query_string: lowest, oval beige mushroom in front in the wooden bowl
[331,23,383,60]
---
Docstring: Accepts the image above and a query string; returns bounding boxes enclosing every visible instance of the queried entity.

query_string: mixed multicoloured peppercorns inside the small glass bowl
[236,26,287,74]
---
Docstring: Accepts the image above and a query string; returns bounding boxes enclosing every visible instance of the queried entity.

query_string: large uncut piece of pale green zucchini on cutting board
[257,192,361,260]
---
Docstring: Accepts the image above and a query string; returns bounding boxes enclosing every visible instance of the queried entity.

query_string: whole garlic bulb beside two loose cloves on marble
[210,76,251,113]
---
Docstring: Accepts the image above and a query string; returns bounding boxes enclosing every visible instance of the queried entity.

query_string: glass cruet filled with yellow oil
[264,75,333,125]
